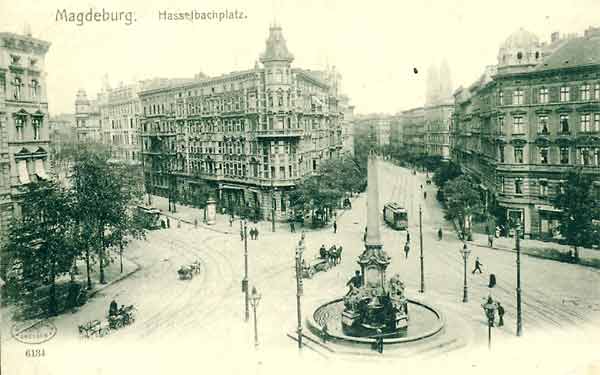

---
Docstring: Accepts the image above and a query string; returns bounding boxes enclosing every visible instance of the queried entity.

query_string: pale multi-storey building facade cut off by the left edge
[0,33,50,238]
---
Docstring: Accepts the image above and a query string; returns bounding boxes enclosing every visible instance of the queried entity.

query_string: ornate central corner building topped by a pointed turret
[139,26,343,220]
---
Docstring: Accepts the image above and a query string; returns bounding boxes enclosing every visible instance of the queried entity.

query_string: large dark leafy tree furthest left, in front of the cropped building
[5,180,77,316]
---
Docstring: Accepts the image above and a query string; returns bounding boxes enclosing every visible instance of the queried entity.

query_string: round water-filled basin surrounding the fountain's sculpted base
[307,298,444,344]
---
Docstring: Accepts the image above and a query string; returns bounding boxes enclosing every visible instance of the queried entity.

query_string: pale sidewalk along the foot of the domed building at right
[469,233,600,268]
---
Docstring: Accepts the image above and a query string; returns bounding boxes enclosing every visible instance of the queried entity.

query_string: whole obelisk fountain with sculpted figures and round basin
[309,151,443,343]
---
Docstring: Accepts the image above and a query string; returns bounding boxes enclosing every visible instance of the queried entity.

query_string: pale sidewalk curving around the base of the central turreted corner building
[152,194,361,235]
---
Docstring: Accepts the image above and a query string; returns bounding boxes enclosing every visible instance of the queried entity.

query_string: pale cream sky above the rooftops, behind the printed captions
[0,0,600,115]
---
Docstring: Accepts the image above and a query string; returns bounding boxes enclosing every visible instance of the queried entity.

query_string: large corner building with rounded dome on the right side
[452,28,600,237]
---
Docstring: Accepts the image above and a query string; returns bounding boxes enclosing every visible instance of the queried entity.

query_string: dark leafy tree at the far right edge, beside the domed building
[552,169,598,259]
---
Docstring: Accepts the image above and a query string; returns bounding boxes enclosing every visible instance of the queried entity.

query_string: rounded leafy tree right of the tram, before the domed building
[444,176,484,241]
